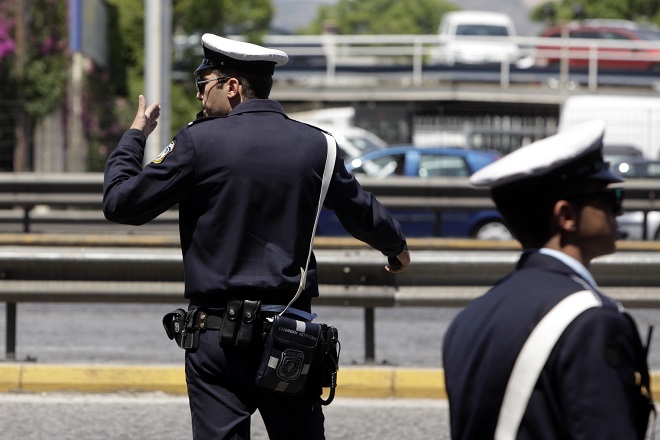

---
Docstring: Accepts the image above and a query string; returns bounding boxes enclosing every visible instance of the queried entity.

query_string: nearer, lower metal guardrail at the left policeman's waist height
[0,239,660,362]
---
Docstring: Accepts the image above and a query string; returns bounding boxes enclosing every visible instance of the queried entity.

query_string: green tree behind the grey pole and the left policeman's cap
[90,0,273,170]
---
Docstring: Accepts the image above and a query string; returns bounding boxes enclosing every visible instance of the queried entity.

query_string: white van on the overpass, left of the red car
[431,11,521,66]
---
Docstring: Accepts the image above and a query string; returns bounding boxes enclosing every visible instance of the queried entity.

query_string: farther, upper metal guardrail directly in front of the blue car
[0,173,660,237]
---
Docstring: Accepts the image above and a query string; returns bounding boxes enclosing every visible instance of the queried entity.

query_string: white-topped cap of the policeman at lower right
[470,120,623,188]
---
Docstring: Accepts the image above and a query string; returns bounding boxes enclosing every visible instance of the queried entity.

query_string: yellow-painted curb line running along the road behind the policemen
[0,363,660,400]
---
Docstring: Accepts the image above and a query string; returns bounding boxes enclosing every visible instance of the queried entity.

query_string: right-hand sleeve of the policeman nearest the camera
[554,308,651,440]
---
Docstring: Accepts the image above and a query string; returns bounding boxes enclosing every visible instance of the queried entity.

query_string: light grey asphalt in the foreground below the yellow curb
[0,393,449,440]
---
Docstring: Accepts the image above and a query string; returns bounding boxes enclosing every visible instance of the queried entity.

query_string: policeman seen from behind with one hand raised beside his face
[103,34,410,440]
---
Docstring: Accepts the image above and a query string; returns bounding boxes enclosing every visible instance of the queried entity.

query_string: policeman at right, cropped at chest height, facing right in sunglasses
[443,121,653,440]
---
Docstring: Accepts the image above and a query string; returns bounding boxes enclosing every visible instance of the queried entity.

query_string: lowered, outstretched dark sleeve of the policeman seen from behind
[324,154,406,256]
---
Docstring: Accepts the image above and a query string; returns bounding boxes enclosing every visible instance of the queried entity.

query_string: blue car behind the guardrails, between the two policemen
[318,145,511,240]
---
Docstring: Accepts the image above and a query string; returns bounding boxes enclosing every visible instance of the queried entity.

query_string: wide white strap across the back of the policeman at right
[495,290,602,440]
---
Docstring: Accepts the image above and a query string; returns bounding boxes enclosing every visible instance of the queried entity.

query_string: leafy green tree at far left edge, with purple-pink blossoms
[0,0,68,171]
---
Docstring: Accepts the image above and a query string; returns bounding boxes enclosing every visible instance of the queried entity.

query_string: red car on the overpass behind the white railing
[536,23,660,72]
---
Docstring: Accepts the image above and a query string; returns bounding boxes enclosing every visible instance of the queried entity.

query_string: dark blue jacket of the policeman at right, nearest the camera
[443,252,651,440]
